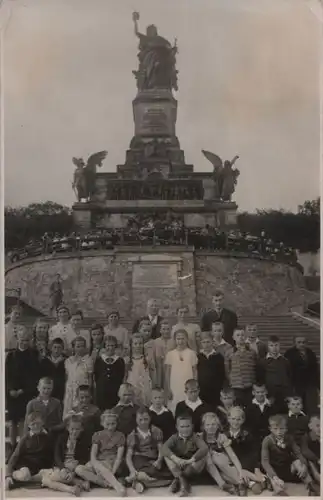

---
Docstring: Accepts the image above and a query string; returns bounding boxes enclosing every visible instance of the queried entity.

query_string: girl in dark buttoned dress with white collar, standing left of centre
[94,335,125,411]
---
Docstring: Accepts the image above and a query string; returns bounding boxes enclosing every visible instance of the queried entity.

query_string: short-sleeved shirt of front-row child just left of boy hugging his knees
[127,425,163,459]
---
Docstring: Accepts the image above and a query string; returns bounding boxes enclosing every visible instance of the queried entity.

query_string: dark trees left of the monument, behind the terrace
[4,201,73,250]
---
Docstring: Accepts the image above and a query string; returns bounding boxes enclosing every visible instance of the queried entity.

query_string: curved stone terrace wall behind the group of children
[6,247,309,317]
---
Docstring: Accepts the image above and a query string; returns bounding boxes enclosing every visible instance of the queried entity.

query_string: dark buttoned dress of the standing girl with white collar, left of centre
[94,356,125,411]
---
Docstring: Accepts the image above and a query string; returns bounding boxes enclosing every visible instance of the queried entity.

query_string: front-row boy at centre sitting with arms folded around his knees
[162,415,208,496]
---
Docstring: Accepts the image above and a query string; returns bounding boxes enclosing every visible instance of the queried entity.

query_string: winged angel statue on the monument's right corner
[202,149,240,201]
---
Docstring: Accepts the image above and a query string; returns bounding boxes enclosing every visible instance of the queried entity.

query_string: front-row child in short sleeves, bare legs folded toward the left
[76,410,126,496]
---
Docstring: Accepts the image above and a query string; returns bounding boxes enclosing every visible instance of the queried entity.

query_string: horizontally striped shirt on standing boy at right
[229,349,257,389]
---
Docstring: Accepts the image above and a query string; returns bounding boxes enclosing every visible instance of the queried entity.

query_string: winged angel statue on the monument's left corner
[72,151,108,201]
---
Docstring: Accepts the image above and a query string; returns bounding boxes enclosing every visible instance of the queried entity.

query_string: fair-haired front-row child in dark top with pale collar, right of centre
[226,406,266,496]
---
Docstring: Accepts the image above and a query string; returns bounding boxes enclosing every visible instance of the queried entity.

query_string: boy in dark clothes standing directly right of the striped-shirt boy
[261,335,291,413]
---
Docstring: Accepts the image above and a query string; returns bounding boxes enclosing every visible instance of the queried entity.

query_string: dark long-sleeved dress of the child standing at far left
[5,349,40,423]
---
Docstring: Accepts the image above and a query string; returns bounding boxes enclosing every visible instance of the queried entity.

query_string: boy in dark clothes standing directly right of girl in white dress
[197,332,225,409]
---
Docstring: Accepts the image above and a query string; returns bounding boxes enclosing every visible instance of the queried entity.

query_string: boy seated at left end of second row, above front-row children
[24,377,64,432]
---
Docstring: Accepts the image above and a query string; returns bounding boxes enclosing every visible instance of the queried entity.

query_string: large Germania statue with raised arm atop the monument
[132,12,178,90]
